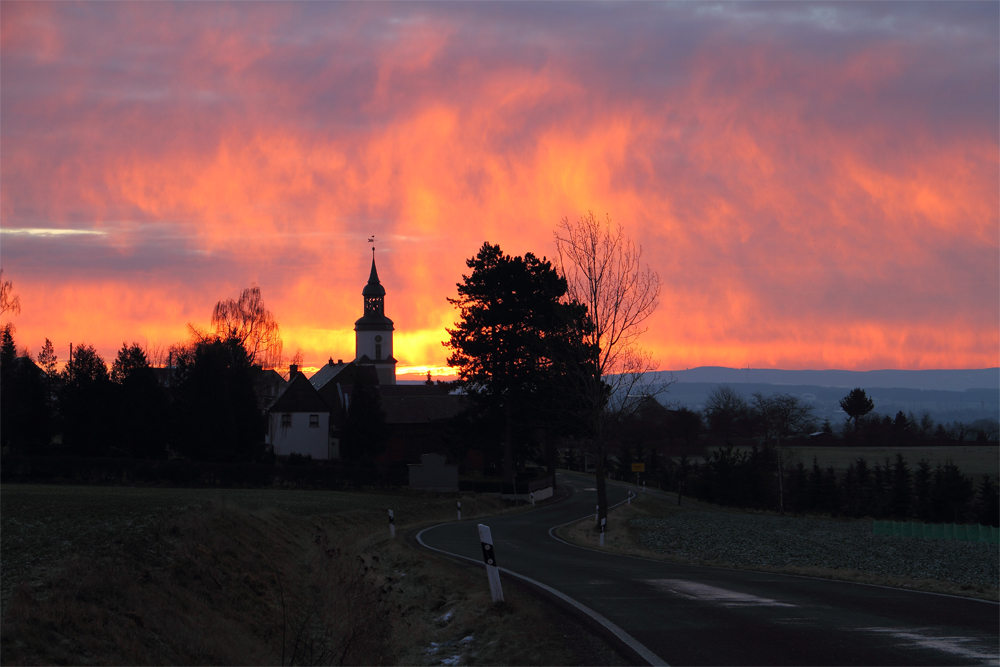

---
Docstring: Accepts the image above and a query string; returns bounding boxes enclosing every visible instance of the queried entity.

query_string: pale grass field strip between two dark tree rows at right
[709,445,1000,482]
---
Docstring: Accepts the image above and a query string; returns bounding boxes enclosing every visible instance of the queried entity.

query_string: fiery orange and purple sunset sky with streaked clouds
[0,0,1000,374]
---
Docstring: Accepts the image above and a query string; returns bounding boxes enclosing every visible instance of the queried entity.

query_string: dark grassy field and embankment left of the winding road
[0,484,622,665]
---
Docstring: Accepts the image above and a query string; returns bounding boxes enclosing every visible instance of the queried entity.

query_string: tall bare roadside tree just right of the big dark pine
[555,212,663,518]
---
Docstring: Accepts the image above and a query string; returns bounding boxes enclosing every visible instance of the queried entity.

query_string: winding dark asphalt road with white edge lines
[418,475,1000,665]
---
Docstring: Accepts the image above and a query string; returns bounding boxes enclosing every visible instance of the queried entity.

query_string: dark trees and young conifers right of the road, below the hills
[567,385,1000,526]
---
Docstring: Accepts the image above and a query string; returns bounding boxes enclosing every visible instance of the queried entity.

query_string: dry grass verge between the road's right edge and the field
[556,480,1000,601]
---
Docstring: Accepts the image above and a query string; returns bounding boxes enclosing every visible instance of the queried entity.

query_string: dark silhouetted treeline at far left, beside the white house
[0,325,269,463]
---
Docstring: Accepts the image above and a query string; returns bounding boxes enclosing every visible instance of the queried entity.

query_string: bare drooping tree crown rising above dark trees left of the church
[212,283,282,368]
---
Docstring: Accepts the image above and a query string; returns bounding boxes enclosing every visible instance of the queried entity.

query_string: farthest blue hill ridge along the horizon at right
[662,366,1000,391]
